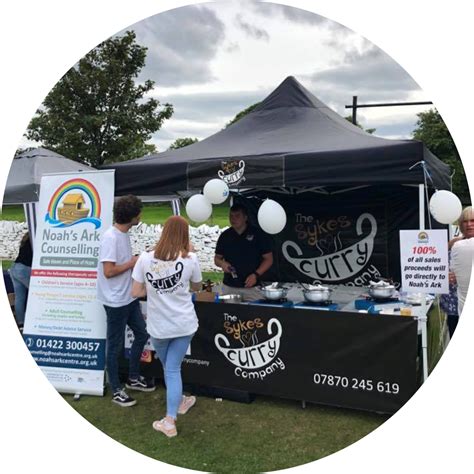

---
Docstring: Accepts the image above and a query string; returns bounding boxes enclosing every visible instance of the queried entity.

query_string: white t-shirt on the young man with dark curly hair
[97,226,135,308]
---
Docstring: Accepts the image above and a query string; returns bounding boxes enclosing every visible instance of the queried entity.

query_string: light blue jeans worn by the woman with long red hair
[151,334,194,419]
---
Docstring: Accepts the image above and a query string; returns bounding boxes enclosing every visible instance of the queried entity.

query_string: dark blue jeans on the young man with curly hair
[104,300,149,392]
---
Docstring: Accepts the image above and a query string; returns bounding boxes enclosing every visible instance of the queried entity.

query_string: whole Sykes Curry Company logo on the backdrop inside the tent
[282,213,380,284]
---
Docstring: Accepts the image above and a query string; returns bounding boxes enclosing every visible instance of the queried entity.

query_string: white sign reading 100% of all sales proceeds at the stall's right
[400,230,449,294]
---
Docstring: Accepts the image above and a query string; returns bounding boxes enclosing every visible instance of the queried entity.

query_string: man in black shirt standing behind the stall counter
[214,204,273,301]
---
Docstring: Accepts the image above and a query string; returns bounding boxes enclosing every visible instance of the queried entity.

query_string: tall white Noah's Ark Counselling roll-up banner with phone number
[23,171,114,395]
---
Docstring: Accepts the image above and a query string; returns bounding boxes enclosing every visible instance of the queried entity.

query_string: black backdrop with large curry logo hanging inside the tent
[235,186,446,286]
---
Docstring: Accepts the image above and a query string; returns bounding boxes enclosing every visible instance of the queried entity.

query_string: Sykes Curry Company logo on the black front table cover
[214,313,285,380]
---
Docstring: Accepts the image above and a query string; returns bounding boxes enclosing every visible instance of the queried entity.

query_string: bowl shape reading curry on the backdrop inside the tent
[282,213,377,283]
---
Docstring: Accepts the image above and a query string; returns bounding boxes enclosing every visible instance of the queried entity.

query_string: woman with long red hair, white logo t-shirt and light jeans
[132,216,202,437]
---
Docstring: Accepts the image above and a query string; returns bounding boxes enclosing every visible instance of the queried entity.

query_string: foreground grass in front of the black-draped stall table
[64,385,388,473]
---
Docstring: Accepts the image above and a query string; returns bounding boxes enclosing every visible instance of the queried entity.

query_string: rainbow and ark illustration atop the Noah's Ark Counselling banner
[45,179,101,229]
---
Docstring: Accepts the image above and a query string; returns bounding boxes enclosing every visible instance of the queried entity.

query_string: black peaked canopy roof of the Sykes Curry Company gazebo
[105,77,450,196]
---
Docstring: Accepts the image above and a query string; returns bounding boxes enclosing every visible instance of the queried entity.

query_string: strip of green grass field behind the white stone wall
[0,202,229,227]
